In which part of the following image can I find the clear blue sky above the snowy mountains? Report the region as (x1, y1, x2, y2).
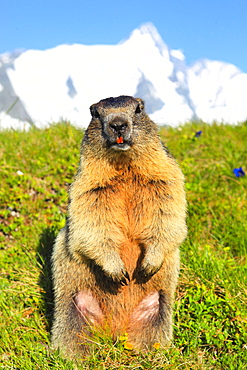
(0, 0, 247, 72)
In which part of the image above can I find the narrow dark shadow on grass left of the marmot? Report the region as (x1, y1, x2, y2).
(37, 227, 58, 331)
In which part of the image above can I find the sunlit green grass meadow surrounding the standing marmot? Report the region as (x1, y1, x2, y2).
(0, 123, 247, 370)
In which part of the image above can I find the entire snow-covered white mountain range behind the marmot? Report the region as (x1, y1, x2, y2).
(0, 23, 247, 128)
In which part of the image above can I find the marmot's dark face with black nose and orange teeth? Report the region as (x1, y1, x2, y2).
(90, 96, 144, 151)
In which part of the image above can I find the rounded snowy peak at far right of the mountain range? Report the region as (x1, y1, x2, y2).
(187, 59, 247, 123)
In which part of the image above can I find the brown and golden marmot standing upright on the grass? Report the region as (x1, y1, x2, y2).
(52, 96, 186, 357)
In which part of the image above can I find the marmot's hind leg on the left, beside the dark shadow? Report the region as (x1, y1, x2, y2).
(52, 227, 103, 357)
